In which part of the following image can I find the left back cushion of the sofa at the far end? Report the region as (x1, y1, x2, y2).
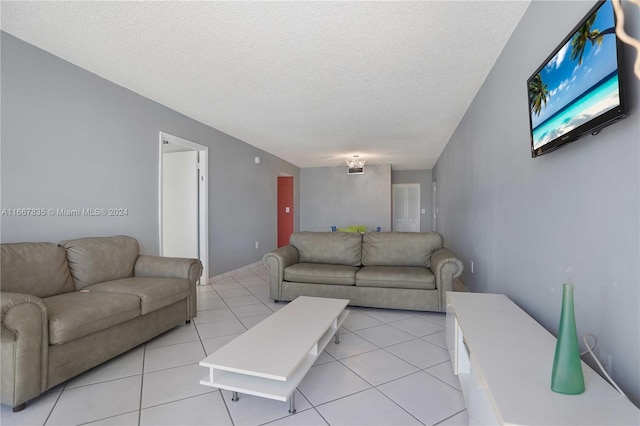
(289, 232, 362, 266)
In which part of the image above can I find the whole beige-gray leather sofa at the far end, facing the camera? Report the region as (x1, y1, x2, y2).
(263, 232, 463, 312)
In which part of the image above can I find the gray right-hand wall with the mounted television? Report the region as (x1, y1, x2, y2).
(434, 1, 640, 404)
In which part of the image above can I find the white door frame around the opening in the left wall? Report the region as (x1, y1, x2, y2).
(158, 132, 209, 285)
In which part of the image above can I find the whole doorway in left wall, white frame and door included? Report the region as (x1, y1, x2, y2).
(159, 132, 209, 284)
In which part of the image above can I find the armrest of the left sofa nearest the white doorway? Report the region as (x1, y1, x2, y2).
(133, 255, 208, 319)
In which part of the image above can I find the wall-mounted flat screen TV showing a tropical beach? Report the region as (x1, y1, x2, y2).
(527, 0, 629, 158)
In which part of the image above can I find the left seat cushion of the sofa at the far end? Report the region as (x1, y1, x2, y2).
(284, 263, 358, 285)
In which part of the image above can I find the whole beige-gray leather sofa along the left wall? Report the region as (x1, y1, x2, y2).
(0, 236, 202, 411)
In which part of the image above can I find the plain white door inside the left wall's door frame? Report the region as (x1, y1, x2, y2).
(162, 151, 199, 259)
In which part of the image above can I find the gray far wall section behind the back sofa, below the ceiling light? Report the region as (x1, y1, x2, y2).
(300, 164, 391, 231)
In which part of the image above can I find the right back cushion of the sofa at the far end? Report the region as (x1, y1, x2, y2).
(362, 232, 444, 268)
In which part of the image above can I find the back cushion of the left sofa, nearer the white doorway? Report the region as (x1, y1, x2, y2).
(60, 235, 140, 290)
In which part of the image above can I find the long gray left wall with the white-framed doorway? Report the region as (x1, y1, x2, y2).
(0, 32, 300, 276)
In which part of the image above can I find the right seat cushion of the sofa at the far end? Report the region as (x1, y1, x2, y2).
(356, 266, 436, 290)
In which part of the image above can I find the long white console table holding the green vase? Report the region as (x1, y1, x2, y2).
(446, 292, 640, 425)
